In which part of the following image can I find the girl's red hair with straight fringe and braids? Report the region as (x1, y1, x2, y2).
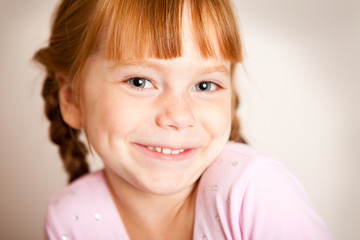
(34, 0, 245, 182)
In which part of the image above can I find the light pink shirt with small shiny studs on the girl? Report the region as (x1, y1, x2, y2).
(45, 142, 333, 240)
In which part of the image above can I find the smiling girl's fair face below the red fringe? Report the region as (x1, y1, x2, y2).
(79, 31, 231, 194)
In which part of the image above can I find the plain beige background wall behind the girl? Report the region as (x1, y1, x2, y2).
(0, 0, 360, 240)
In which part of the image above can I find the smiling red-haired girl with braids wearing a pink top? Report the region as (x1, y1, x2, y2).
(35, 0, 332, 240)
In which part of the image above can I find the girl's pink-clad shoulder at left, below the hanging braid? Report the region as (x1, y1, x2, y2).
(45, 171, 126, 239)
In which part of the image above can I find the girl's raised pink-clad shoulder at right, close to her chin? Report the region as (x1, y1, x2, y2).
(197, 143, 332, 239)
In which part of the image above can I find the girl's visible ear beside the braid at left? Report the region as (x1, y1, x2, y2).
(55, 74, 83, 129)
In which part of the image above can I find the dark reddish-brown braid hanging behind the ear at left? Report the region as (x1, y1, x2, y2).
(42, 74, 89, 182)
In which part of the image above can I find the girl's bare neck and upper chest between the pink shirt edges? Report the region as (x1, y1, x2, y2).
(105, 169, 196, 239)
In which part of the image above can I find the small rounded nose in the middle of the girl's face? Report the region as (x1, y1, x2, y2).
(156, 94, 195, 130)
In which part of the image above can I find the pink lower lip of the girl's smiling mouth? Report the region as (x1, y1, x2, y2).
(133, 143, 196, 161)
